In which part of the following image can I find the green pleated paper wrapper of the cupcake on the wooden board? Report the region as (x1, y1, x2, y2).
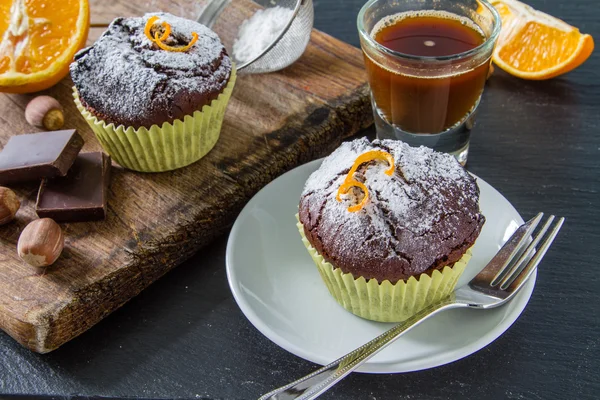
(73, 67, 236, 172)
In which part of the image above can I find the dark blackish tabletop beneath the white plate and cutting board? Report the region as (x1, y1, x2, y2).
(0, 0, 600, 400)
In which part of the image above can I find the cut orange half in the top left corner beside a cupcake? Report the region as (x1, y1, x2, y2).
(0, 0, 90, 93)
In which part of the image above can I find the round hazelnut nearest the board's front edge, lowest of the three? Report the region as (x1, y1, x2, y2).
(17, 218, 65, 267)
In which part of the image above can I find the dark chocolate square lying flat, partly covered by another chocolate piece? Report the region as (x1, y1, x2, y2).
(35, 152, 110, 222)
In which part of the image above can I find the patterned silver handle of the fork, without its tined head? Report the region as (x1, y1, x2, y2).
(259, 294, 461, 400)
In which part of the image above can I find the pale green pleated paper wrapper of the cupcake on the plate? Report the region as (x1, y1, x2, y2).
(297, 217, 471, 322)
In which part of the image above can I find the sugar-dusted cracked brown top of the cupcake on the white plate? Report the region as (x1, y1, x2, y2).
(299, 138, 485, 283)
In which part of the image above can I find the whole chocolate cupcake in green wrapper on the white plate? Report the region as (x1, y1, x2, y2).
(299, 139, 485, 322)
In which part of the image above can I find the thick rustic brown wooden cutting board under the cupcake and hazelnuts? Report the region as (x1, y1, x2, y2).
(0, 0, 372, 353)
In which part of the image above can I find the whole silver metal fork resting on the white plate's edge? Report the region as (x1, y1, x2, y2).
(259, 213, 565, 400)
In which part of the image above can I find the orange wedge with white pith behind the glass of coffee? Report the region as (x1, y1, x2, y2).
(491, 0, 594, 80)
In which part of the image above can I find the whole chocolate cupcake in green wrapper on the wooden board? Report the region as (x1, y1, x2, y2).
(71, 13, 236, 172)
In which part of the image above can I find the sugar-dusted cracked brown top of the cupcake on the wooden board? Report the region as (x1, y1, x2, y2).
(71, 13, 232, 128)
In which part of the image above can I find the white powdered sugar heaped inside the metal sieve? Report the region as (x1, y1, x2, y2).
(233, 6, 294, 63)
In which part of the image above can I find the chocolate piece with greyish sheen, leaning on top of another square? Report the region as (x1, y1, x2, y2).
(0, 129, 83, 185)
